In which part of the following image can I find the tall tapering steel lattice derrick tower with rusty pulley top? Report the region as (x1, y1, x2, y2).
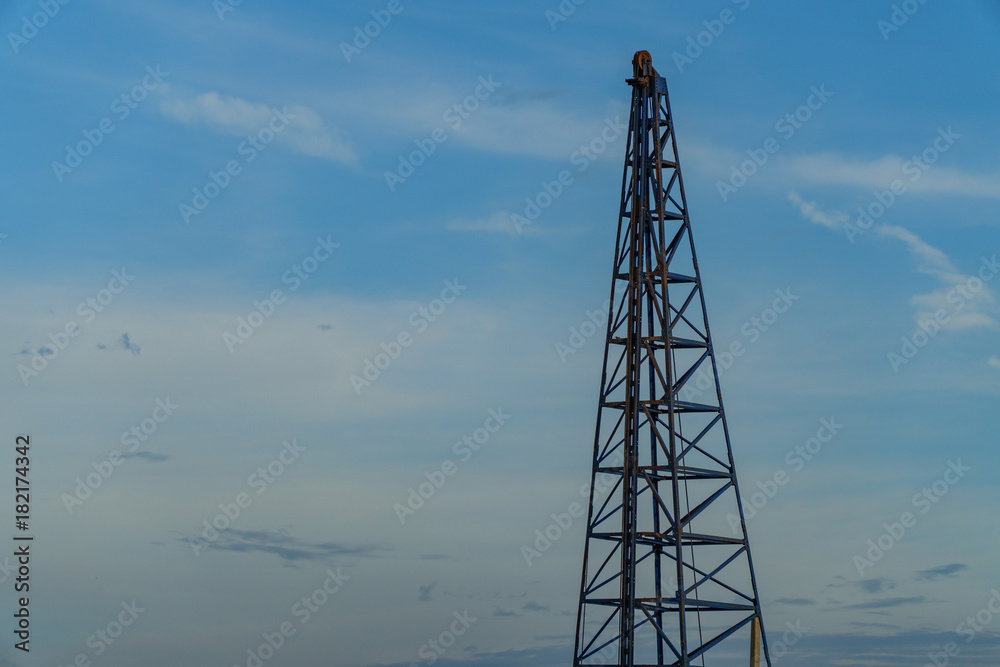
(573, 51, 771, 667)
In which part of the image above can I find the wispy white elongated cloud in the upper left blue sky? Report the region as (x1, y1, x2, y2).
(160, 88, 358, 166)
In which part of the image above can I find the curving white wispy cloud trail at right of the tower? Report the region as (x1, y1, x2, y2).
(788, 191, 998, 331)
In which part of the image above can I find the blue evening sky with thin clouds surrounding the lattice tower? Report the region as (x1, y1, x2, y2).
(0, 0, 1000, 667)
